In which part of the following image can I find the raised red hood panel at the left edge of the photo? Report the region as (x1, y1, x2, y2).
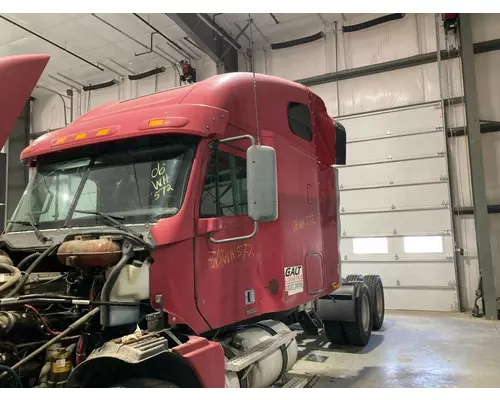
(0, 54, 50, 147)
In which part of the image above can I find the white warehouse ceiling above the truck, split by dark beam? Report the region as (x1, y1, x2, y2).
(0, 14, 344, 96)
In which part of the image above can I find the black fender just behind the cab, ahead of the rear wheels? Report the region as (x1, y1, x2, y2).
(316, 282, 364, 322)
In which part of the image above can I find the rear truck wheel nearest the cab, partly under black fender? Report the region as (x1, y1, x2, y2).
(341, 282, 372, 346)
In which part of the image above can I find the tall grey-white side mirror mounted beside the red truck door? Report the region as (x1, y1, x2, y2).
(247, 145, 278, 222)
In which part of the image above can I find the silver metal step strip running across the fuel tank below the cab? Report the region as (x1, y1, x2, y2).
(226, 331, 297, 372)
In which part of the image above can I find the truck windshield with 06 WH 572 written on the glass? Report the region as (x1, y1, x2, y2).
(7, 138, 196, 232)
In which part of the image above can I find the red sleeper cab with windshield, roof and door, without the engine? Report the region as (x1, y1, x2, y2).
(13, 73, 339, 334)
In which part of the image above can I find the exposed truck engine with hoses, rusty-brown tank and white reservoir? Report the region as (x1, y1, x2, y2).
(0, 236, 152, 387)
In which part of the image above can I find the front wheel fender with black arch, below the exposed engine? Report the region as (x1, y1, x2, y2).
(66, 335, 224, 388)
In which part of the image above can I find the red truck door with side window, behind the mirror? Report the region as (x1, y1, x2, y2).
(195, 142, 258, 326)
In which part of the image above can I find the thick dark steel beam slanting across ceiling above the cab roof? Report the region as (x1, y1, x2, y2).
(167, 14, 241, 74)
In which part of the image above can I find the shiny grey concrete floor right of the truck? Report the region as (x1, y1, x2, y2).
(290, 312, 500, 388)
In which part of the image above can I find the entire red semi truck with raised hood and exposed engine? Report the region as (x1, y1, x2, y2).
(0, 55, 384, 388)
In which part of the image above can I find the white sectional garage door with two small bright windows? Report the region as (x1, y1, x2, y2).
(338, 103, 458, 311)
